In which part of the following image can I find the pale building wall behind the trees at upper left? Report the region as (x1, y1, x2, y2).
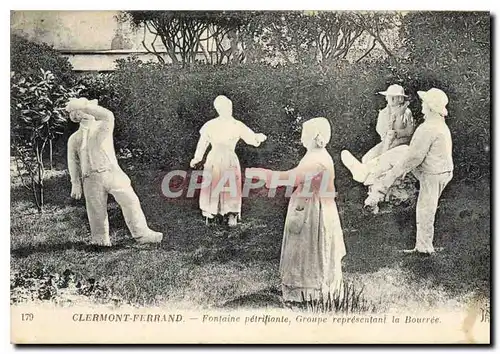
(11, 11, 208, 72)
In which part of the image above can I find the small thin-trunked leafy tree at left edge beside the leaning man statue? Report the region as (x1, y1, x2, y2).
(11, 69, 80, 212)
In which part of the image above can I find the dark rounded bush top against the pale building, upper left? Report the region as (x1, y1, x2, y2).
(10, 35, 75, 84)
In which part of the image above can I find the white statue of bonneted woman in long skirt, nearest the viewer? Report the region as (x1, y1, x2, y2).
(246, 117, 346, 303)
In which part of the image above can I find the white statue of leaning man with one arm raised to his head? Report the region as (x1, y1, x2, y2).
(66, 98, 163, 246)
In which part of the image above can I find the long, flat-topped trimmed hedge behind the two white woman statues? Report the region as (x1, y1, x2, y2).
(101, 61, 398, 176)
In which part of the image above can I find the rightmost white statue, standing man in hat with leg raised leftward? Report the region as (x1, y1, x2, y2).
(341, 88, 454, 254)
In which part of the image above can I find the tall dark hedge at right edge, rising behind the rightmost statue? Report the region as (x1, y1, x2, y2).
(401, 11, 491, 180)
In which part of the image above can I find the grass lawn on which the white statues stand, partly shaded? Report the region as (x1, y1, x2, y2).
(11, 158, 490, 311)
